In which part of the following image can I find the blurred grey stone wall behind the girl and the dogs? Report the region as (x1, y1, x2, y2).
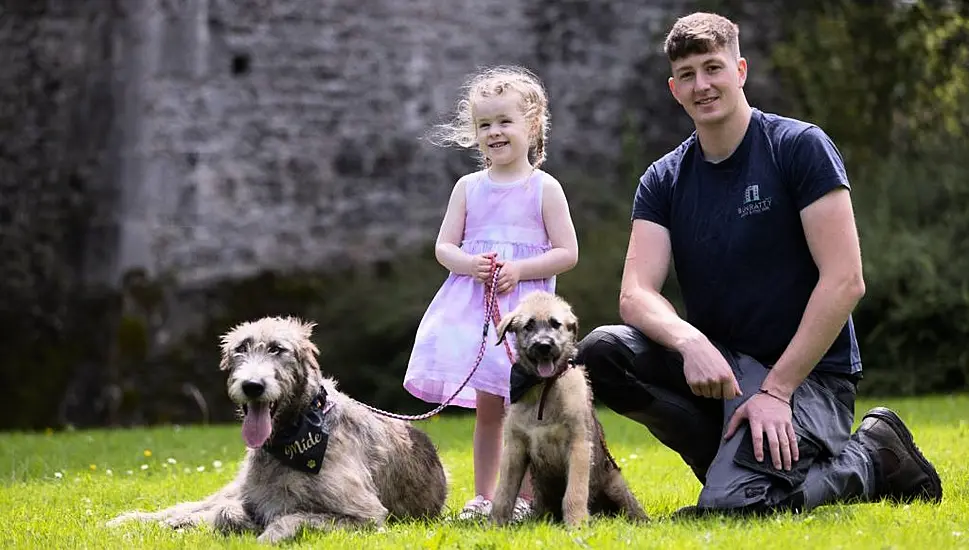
(0, 0, 788, 429)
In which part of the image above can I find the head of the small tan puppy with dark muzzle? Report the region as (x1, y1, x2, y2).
(498, 291, 579, 378)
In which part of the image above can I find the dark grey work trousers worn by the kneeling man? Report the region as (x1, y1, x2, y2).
(576, 325, 875, 513)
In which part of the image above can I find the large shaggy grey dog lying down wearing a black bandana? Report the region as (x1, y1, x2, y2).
(109, 317, 447, 542)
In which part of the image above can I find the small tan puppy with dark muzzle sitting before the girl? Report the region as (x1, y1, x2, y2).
(491, 292, 648, 526)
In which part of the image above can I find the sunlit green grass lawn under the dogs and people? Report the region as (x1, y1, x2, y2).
(0, 396, 969, 550)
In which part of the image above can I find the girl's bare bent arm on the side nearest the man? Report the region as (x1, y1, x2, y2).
(498, 176, 579, 286)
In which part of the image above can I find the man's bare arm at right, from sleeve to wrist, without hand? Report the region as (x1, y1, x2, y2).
(761, 188, 865, 401)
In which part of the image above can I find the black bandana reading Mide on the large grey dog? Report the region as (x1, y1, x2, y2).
(262, 387, 333, 474)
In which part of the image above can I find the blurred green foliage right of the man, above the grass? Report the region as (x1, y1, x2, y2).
(773, 0, 969, 393)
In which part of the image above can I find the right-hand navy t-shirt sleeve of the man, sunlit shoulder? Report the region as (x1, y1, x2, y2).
(788, 126, 851, 210)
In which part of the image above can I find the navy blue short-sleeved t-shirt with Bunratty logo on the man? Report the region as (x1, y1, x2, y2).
(632, 109, 861, 374)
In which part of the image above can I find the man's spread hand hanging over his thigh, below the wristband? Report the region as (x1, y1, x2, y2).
(723, 393, 800, 471)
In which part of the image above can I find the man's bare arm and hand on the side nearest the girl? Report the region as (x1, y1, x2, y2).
(619, 220, 740, 399)
